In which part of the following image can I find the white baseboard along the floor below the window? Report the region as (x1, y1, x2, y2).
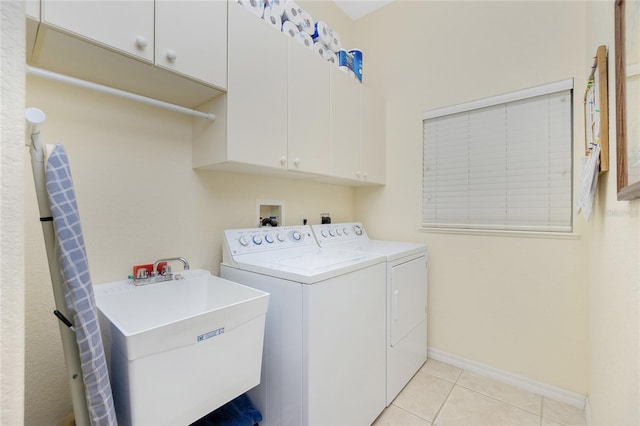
(427, 347, 587, 410)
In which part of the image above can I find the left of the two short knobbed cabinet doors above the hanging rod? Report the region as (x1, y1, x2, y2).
(42, 0, 154, 62)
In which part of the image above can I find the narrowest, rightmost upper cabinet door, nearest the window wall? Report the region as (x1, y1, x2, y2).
(360, 86, 387, 184)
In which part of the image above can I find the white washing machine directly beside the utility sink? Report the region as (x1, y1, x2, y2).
(220, 226, 386, 426)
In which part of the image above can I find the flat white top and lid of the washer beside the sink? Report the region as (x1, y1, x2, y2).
(233, 248, 385, 284)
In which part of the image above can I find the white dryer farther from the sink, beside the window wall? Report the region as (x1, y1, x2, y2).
(312, 223, 427, 405)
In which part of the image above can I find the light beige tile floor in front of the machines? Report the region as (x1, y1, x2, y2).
(374, 359, 587, 426)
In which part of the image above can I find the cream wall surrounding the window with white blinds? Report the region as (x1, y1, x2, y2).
(356, 0, 591, 395)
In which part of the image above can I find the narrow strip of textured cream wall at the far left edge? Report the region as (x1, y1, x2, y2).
(0, 1, 25, 425)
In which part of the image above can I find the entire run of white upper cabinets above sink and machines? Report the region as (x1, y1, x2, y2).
(37, 0, 386, 185)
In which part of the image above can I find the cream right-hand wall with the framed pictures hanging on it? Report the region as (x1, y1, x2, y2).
(585, 1, 640, 425)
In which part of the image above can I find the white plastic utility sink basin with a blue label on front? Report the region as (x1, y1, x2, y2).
(94, 269, 269, 425)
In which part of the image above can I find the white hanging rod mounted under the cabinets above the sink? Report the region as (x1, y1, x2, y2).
(27, 65, 216, 121)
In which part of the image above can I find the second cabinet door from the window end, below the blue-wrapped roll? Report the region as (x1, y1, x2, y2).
(331, 68, 361, 179)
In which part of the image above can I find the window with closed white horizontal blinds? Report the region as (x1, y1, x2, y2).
(422, 80, 573, 232)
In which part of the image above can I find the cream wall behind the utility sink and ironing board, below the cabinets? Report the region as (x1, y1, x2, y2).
(24, 77, 353, 425)
